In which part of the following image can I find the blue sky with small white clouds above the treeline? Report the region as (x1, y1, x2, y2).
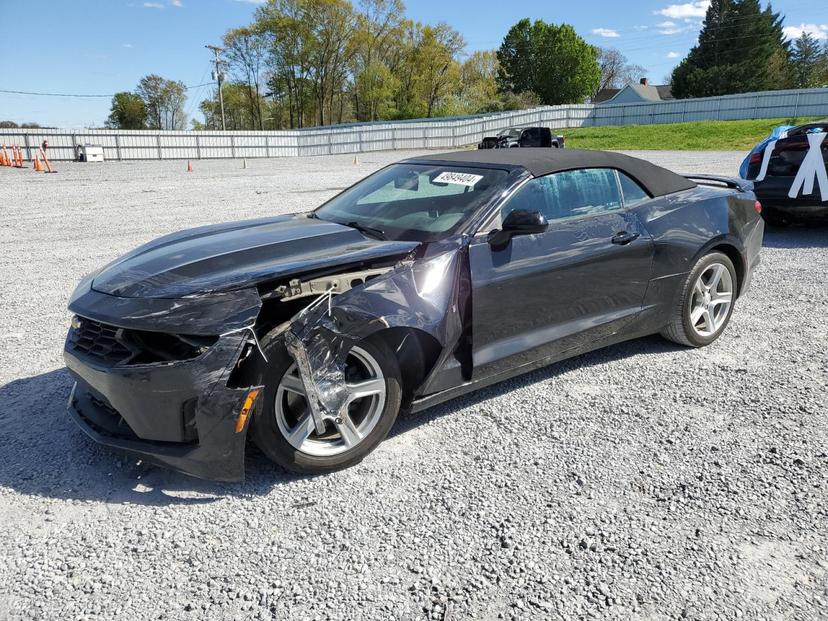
(0, 0, 828, 127)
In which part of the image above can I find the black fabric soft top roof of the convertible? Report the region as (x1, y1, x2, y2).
(405, 148, 696, 196)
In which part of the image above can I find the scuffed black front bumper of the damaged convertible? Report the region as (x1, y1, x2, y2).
(64, 333, 253, 481)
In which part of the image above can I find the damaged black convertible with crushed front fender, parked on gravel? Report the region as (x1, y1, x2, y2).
(65, 149, 763, 481)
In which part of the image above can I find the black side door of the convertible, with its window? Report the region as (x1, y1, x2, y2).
(469, 169, 653, 378)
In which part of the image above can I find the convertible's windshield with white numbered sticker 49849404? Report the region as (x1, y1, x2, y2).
(313, 164, 508, 241)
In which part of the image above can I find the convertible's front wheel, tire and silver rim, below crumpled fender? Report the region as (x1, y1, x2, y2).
(252, 340, 402, 474)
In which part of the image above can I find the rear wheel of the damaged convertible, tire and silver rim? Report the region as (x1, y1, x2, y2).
(661, 252, 738, 347)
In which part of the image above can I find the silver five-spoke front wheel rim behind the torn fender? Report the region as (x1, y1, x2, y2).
(274, 346, 386, 457)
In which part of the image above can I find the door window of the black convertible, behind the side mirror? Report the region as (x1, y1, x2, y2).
(500, 168, 621, 222)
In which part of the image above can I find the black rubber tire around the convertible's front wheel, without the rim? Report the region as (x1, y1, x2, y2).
(251, 337, 402, 474)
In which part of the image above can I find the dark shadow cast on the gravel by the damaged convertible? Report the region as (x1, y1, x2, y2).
(0, 337, 682, 506)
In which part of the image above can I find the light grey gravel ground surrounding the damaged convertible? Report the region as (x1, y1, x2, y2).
(0, 152, 828, 620)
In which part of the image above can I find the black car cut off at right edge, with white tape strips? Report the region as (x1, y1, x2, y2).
(741, 119, 828, 225)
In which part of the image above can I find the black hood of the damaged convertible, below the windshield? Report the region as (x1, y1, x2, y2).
(92, 215, 418, 298)
